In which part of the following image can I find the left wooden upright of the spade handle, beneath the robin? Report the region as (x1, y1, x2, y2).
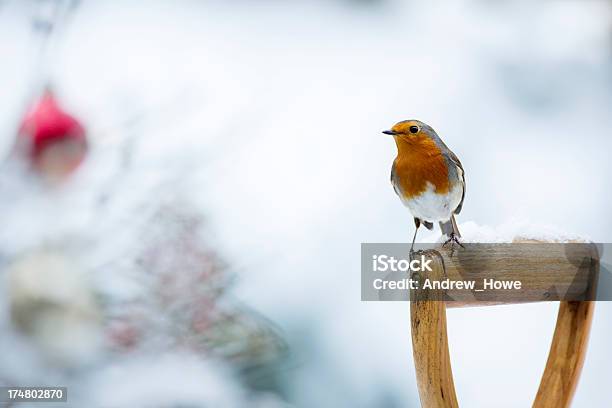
(410, 253, 458, 408)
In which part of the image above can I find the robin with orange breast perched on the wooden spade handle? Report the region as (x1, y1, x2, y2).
(383, 120, 465, 252)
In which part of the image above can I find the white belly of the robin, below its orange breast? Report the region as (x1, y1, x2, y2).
(402, 183, 463, 222)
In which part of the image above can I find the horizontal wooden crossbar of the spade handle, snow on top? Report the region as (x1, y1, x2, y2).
(428, 242, 598, 308)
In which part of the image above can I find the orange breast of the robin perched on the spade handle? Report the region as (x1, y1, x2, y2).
(393, 135, 451, 199)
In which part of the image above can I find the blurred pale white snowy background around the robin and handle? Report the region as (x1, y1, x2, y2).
(0, 0, 612, 407)
